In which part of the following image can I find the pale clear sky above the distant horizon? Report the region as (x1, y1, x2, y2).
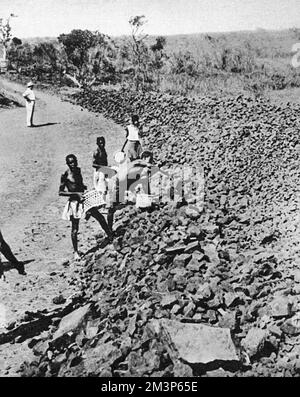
(0, 0, 300, 38)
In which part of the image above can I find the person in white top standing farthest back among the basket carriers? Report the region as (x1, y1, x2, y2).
(122, 114, 142, 161)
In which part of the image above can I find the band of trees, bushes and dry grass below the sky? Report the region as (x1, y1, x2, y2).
(8, 25, 300, 95)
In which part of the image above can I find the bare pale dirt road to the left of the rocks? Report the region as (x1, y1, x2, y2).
(0, 80, 124, 376)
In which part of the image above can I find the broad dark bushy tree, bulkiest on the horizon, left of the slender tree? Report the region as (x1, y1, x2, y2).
(58, 29, 113, 87)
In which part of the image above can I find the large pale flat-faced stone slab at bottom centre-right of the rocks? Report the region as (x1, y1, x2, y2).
(161, 319, 240, 364)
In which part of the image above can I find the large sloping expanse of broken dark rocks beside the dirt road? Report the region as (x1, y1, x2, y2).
(19, 90, 300, 377)
